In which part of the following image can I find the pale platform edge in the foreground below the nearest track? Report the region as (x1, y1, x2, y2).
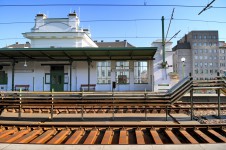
(0, 144, 226, 150)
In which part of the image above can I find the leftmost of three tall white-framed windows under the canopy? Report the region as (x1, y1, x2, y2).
(97, 61, 111, 84)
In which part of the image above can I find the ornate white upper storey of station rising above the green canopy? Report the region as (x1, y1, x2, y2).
(23, 13, 98, 48)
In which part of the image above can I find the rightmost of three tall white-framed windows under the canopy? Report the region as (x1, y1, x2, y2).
(134, 61, 148, 83)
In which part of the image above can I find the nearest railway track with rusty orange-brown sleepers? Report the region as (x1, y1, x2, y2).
(0, 124, 226, 145)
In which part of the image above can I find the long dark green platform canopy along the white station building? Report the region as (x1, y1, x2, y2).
(0, 47, 157, 62)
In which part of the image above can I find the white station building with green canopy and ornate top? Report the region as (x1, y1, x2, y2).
(0, 13, 157, 91)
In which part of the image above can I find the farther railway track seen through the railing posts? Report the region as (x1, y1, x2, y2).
(3, 103, 226, 116)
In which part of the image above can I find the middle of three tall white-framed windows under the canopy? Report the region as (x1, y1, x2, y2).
(116, 61, 129, 84)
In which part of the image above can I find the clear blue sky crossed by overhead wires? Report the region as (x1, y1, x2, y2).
(0, 0, 226, 47)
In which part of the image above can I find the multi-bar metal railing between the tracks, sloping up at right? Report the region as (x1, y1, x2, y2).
(0, 76, 226, 106)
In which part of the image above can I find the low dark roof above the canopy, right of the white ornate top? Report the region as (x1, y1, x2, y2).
(94, 40, 135, 47)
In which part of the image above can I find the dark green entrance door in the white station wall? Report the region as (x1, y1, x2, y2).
(50, 66, 64, 92)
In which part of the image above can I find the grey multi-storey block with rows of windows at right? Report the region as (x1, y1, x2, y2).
(173, 31, 225, 80)
